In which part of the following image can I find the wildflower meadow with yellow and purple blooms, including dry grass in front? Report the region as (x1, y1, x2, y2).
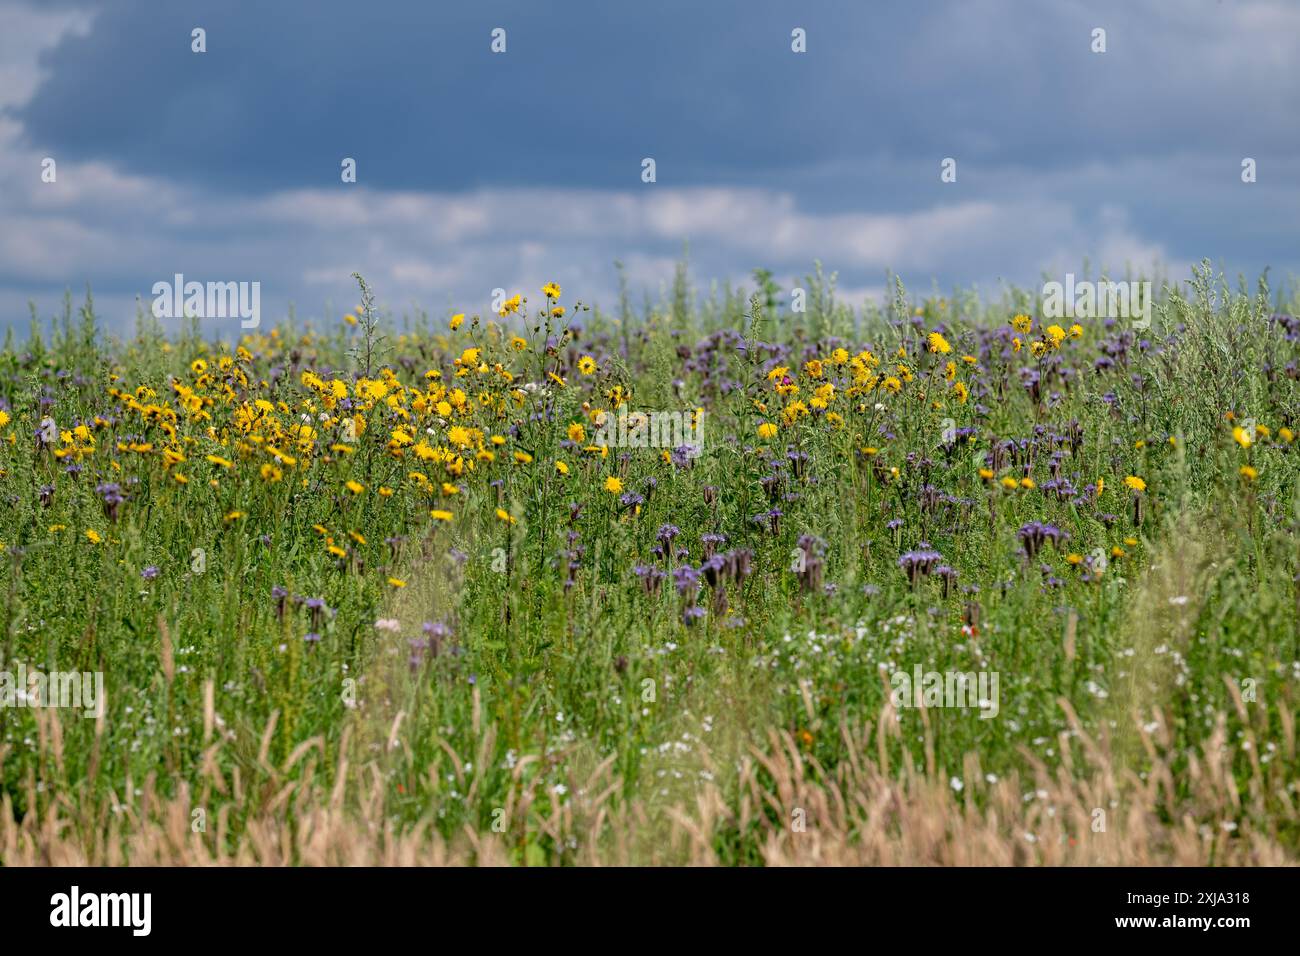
(0, 267, 1300, 865)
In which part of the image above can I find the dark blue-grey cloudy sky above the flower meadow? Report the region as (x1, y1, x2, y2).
(0, 0, 1300, 329)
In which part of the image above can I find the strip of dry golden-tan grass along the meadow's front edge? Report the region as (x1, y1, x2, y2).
(0, 701, 1296, 866)
